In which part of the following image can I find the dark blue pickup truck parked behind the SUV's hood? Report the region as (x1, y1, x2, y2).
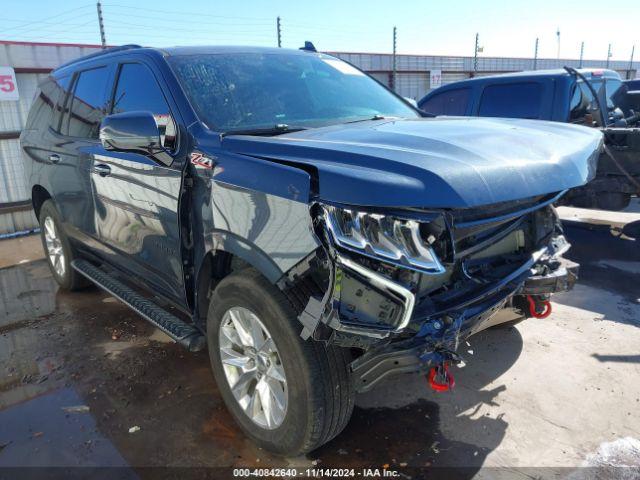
(418, 68, 640, 210)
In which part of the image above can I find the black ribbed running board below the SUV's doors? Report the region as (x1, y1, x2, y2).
(71, 260, 206, 352)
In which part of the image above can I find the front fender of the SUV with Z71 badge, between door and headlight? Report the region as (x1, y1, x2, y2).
(190, 136, 319, 324)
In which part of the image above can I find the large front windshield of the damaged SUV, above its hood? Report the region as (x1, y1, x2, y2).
(168, 53, 419, 132)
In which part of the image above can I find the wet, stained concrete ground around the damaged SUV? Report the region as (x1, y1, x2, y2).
(0, 212, 640, 478)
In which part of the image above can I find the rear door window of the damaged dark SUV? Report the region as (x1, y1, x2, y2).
(61, 67, 109, 138)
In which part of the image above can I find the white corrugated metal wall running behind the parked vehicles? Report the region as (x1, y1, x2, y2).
(0, 41, 640, 235)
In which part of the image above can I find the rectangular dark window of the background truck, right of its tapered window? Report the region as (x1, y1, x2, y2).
(478, 82, 542, 119)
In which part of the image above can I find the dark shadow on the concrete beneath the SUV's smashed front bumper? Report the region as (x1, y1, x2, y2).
(311, 327, 523, 478)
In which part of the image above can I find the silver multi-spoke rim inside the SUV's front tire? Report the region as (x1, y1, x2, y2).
(218, 307, 288, 430)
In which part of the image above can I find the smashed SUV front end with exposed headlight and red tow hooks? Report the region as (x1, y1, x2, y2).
(280, 189, 578, 391)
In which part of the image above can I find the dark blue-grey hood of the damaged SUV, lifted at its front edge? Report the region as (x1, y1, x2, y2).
(222, 117, 602, 208)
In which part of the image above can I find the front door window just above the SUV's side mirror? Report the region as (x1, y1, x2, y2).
(112, 63, 176, 150)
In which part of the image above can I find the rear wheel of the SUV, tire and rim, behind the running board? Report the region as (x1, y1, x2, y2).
(39, 200, 91, 291)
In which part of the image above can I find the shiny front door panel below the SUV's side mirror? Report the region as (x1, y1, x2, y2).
(91, 152, 184, 302)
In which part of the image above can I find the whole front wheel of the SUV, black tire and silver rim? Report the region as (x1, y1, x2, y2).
(207, 269, 355, 456)
